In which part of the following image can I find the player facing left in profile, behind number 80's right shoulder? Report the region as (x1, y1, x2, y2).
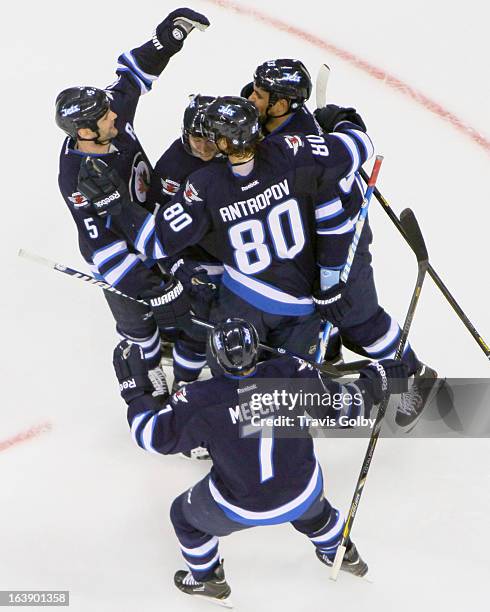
(242, 59, 438, 428)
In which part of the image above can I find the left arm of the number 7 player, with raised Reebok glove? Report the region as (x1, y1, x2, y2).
(113, 341, 208, 455)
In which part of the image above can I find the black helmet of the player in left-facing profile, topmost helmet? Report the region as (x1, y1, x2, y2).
(254, 59, 312, 110)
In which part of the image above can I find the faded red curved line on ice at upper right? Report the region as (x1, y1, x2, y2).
(204, 0, 490, 153)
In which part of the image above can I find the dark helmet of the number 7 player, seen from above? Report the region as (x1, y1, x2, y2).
(208, 319, 259, 376)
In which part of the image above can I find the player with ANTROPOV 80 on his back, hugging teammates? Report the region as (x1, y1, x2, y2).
(80, 97, 373, 366)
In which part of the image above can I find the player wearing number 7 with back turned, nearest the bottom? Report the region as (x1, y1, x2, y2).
(114, 319, 407, 601)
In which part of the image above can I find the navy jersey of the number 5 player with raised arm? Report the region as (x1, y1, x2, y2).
(58, 34, 185, 297)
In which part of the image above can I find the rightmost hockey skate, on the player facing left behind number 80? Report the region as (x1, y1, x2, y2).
(395, 363, 442, 433)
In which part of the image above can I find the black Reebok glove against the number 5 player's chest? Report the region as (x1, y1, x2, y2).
(78, 157, 129, 217)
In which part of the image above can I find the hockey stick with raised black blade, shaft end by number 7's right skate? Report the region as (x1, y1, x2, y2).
(330, 208, 429, 580)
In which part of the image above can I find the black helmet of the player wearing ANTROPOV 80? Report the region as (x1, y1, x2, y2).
(202, 96, 260, 149)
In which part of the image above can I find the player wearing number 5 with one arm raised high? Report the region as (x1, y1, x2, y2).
(56, 8, 209, 392)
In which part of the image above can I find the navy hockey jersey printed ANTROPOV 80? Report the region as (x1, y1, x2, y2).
(115, 123, 373, 316)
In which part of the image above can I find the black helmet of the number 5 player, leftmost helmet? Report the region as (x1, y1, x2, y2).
(55, 87, 110, 138)
